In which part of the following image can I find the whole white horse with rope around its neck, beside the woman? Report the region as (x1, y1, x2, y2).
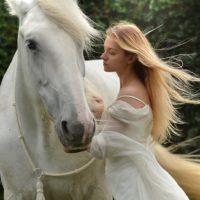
(0, 0, 119, 200)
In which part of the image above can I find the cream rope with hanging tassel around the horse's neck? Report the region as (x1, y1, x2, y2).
(13, 64, 95, 200)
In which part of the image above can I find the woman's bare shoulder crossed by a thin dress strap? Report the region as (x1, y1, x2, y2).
(118, 86, 150, 108)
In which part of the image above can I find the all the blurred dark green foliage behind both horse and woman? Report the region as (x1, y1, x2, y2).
(0, 0, 200, 200)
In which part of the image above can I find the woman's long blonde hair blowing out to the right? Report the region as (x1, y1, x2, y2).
(107, 22, 200, 142)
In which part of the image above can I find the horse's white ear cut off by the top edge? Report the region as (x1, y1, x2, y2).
(6, 0, 35, 18)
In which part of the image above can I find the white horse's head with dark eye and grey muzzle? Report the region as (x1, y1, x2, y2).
(7, 0, 98, 151)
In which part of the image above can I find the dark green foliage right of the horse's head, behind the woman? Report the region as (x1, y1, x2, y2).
(80, 0, 200, 150)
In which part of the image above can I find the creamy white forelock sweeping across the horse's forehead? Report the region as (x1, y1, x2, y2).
(36, 0, 99, 49)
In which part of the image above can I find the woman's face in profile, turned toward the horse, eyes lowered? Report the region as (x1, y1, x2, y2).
(101, 36, 133, 73)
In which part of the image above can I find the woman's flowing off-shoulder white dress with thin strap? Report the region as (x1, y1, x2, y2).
(90, 95, 189, 200)
